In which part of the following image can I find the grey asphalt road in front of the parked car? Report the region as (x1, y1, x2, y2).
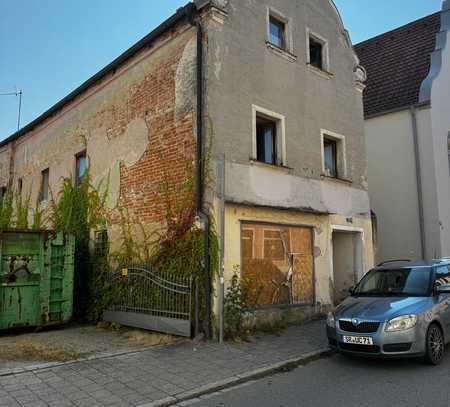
(185, 349, 450, 407)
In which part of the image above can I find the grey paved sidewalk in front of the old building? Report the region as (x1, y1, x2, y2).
(0, 321, 326, 407)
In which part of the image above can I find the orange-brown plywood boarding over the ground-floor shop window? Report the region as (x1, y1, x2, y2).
(241, 224, 314, 305)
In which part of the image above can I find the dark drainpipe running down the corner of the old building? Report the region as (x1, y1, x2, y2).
(188, 3, 211, 339)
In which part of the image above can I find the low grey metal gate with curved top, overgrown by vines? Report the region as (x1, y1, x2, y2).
(103, 265, 192, 337)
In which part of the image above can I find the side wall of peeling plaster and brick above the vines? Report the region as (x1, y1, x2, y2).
(2, 23, 196, 236)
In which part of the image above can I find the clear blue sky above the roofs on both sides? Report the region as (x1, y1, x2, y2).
(0, 0, 441, 140)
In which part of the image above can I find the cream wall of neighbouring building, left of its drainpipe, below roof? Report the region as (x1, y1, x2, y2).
(365, 110, 421, 261)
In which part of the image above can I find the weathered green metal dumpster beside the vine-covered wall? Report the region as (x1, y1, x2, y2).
(0, 230, 75, 329)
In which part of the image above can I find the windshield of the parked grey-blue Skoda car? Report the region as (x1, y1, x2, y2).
(353, 267, 431, 297)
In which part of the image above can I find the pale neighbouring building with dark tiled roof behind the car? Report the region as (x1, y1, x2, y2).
(355, 0, 450, 261)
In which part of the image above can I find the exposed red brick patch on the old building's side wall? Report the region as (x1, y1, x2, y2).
(105, 32, 195, 223)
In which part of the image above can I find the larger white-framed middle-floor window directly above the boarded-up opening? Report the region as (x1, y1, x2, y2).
(252, 105, 286, 166)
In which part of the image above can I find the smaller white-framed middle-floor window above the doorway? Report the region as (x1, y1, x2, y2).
(321, 130, 347, 179)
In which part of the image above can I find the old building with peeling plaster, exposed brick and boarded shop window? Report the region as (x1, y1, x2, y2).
(0, 0, 373, 326)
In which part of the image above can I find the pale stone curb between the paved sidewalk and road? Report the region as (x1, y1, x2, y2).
(138, 348, 333, 407)
